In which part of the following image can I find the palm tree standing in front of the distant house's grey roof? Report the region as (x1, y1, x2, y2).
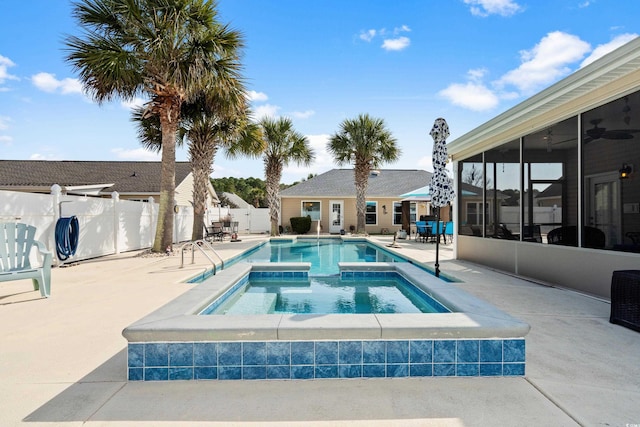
(327, 114, 400, 234)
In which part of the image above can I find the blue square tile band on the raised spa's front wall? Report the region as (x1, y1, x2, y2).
(128, 338, 525, 381)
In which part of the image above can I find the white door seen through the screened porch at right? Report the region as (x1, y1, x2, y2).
(587, 173, 620, 247)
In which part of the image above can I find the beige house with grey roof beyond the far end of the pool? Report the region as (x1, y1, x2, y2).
(280, 169, 432, 234)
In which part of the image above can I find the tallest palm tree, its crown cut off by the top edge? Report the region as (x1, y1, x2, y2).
(66, 0, 243, 252)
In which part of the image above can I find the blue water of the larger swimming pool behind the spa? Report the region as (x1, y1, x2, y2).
(230, 239, 406, 276)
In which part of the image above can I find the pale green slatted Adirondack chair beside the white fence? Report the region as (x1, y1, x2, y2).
(0, 222, 53, 298)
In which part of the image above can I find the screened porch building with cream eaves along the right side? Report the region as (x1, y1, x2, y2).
(447, 38, 640, 298)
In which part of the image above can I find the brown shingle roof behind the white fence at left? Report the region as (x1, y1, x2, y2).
(0, 160, 191, 194)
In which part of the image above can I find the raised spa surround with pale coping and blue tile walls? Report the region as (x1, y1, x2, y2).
(123, 263, 529, 381)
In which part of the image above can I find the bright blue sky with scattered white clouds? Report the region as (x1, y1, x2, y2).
(0, 0, 640, 185)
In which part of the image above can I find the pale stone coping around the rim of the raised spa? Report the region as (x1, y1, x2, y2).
(122, 262, 530, 343)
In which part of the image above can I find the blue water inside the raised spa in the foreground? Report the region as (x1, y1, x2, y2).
(201, 272, 449, 315)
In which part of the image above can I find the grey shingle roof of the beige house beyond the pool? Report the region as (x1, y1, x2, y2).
(280, 169, 432, 198)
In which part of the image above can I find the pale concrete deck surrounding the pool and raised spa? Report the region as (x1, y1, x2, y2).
(0, 236, 640, 426)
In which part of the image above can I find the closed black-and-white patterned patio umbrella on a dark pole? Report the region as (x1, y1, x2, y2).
(429, 118, 456, 277)
